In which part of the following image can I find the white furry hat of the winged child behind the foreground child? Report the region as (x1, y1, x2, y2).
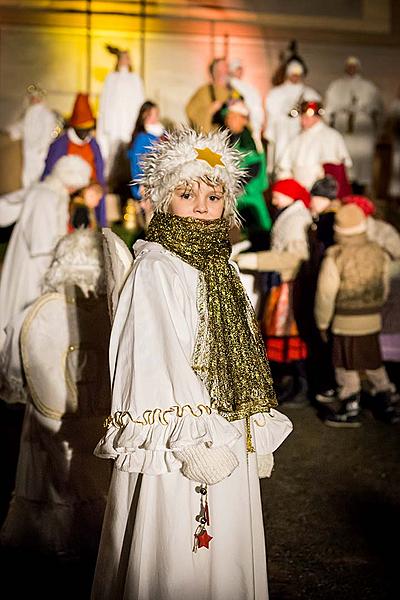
(42, 229, 106, 297)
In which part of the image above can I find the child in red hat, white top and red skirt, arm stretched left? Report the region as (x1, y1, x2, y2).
(235, 179, 312, 405)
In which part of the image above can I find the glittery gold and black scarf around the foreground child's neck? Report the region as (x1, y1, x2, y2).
(146, 213, 277, 421)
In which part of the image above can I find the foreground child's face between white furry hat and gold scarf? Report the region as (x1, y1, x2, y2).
(169, 180, 225, 221)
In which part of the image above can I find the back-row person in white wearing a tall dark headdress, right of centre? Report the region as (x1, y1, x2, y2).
(264, 60, 321, 173)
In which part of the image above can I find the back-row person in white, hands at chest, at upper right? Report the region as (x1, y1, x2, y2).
(325, 56, 384, 193)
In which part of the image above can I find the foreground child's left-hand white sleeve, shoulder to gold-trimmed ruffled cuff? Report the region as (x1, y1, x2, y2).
(95, 246, 240, 475)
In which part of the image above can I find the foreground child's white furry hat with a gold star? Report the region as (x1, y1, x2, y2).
(136, 128, 245, 223)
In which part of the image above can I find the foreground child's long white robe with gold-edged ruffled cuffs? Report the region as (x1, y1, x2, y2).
(92, 240, 292, 600)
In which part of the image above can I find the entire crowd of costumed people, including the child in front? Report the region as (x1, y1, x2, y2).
(0, 39, 400, 600)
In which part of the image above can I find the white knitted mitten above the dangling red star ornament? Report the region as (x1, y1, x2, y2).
(174, 444, 239, 485)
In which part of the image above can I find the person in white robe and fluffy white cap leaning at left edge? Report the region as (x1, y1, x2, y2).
(0, 155, 91, 348)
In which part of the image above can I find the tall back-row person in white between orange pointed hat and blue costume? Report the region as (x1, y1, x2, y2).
(96, 46, 145, 175)
